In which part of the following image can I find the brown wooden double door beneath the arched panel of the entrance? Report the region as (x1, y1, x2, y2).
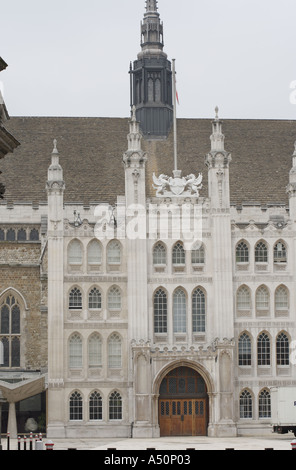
(159, 398, 207, 436)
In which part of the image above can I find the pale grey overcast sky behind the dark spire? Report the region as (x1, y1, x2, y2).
(0, 0, 296, 119)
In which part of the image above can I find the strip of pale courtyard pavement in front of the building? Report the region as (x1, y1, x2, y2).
(2, 434, 296, 452)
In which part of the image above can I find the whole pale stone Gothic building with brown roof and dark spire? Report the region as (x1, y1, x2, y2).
(0, 1, 296, 438)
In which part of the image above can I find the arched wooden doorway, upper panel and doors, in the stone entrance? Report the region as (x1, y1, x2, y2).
(158, 366, 209, 436)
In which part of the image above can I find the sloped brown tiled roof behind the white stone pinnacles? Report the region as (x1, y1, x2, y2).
(1, 117, 296, 204)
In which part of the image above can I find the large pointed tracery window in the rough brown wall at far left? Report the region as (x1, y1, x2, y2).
(0, 294, 21, 367)
